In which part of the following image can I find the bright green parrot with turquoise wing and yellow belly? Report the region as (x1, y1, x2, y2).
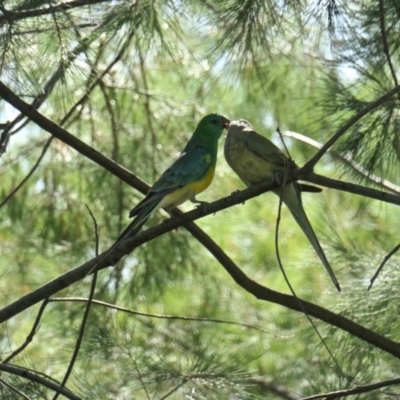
(118, 114, 230, 240)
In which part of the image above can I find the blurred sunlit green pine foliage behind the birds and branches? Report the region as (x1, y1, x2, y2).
(0, 0, 400, 400)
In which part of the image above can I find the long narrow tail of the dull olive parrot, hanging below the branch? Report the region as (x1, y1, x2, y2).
(276, 184, 340, 292)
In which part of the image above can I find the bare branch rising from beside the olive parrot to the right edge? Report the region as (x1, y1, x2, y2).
(303, 85, 400, 170)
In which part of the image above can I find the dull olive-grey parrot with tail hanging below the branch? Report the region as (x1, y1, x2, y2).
(224, 119, 340, 291)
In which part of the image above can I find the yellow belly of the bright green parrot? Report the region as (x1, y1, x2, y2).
(158, 168, 215, 208)
